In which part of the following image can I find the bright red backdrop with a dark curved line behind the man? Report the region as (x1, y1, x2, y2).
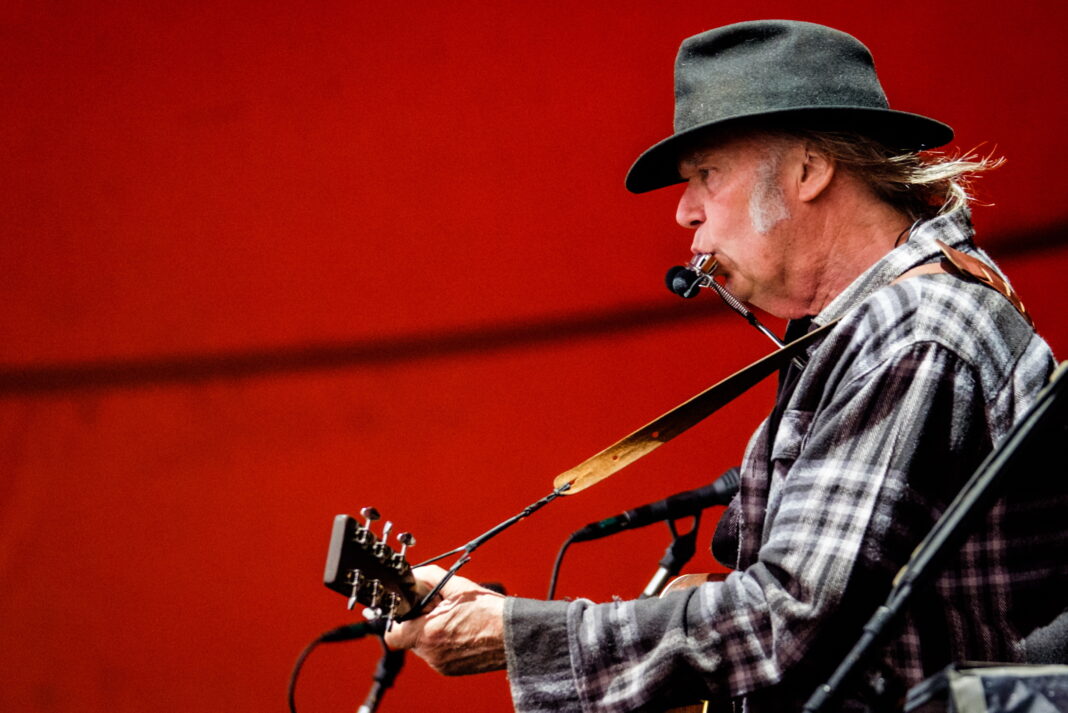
(0, 0, 1068, 713)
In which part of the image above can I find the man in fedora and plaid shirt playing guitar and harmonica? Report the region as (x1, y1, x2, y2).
(387, 21, 1068, 712)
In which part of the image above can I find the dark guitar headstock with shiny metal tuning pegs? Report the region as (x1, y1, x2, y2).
(323, 508, 419, 620)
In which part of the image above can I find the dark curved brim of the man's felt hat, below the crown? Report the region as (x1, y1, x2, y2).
(626, 107, 953, 193)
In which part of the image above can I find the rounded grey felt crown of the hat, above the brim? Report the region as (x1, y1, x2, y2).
(675, 20, 889, 131)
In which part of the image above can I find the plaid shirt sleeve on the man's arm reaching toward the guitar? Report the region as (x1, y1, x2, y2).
(505, 342, 986, 713)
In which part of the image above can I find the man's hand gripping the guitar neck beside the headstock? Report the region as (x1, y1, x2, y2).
(386, 565, 505, 676)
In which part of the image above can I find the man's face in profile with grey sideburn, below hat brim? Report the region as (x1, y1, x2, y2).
(675, 132, 792, 316)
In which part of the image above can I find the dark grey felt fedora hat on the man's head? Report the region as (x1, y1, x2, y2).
(627, 20, 953, 193)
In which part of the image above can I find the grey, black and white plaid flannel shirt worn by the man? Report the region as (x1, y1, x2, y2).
(505, 211, 1068, 713)
